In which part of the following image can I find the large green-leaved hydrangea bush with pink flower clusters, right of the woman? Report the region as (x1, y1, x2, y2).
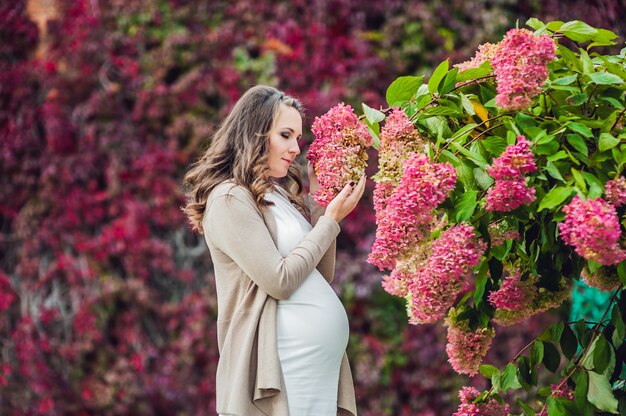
(346, 19, 626, 415)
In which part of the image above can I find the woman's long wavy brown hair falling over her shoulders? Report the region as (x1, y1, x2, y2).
(182, 85, 308, 234)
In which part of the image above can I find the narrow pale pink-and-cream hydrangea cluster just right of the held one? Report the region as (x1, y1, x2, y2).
(372, 108, 423, 223)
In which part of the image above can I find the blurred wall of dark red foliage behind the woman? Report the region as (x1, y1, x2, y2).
(0, 0, 623, 415)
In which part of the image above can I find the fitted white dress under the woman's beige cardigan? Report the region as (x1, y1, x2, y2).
(265, 191, 348, 416)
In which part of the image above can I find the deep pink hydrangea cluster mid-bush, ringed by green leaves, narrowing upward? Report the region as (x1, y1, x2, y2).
(485, 136, 537, 212)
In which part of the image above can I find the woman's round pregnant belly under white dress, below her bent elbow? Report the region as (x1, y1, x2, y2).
(277, 271, 348, 371)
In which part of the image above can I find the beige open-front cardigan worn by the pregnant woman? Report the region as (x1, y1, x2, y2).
(203, 182, 356, 416)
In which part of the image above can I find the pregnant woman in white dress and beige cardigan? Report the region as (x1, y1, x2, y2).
(184, 86, 365, 416)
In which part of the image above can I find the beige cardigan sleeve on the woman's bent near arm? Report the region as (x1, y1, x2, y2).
(204, 193, 340, 299)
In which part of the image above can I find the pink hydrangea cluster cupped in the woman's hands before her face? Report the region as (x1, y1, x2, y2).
(307, 103, 372, 206)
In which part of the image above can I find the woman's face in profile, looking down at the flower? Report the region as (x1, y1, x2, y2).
(267, 104, 302, 178)
